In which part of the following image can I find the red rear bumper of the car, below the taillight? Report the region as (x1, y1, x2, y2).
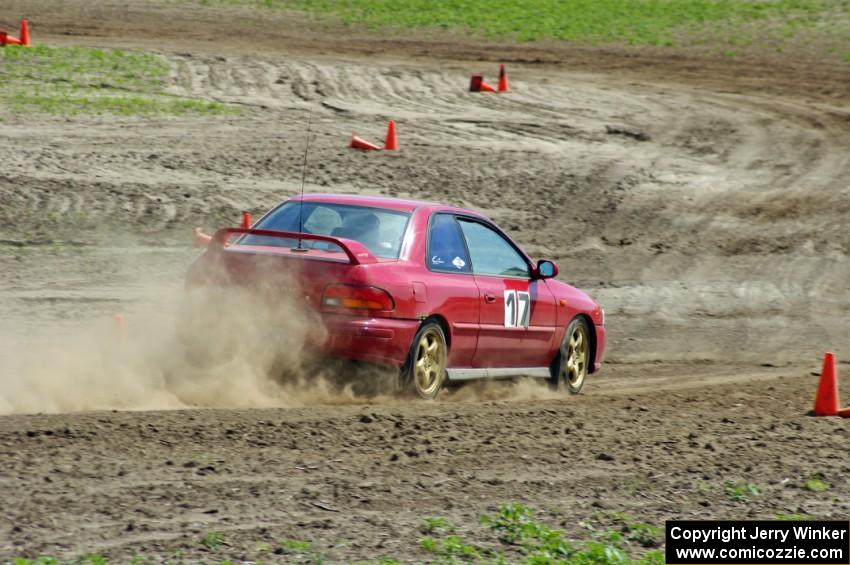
(316, 315, 419, 367)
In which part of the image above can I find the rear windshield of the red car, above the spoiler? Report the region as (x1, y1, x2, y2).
(239, 201, 410, 259)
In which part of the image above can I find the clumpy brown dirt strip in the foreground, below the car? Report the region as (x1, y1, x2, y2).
(0, 368, 850, 562)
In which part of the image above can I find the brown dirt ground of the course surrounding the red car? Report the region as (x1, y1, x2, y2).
(0, 0, 850, 562)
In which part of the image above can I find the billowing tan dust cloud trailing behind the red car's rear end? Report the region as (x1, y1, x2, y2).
(0, 289, 322, 413)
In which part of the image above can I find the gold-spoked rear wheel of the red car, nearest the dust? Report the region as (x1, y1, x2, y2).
(402, 321, 449, 400)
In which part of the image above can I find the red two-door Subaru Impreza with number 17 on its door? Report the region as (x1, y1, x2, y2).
(187, 194, 605, 398)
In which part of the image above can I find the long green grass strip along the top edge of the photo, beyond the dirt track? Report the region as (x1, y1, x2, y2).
(205, 0, 850, 45)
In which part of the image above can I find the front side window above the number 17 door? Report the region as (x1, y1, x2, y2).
(459, 220, 531, 278)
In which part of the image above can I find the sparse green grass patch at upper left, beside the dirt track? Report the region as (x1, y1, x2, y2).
(0, 45, 233, 116)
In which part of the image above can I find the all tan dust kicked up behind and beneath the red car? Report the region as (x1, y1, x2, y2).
(0, 253, 562, 414)
